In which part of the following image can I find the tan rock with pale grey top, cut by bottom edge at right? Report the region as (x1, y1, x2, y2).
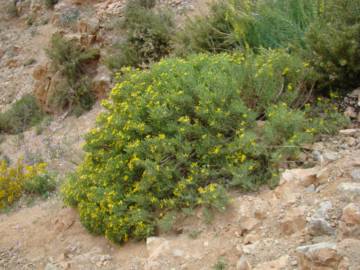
(296, 242, 342, 270)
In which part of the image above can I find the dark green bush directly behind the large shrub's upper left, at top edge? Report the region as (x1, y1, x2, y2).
(107, 0, 174, 69)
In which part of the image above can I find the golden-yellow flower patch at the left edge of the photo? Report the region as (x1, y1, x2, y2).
(0, 160, 47, 209)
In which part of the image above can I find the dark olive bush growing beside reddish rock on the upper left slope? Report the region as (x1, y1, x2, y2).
(47, 33, 99, 114)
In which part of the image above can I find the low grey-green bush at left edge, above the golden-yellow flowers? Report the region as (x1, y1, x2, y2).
(0, 95, 44, 134)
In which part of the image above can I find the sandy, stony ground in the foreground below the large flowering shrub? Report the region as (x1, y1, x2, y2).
(0, 129, 360, 270)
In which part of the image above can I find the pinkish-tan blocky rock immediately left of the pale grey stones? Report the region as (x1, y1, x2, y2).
(280, 208, 306, 235)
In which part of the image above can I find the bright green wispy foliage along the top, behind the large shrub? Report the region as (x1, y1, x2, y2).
(176, 0, 319, 54)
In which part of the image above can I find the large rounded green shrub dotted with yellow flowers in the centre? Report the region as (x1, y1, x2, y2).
(63, 50, 348, 242)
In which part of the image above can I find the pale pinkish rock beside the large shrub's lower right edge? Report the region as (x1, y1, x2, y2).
(280, 167, 319, 187)
